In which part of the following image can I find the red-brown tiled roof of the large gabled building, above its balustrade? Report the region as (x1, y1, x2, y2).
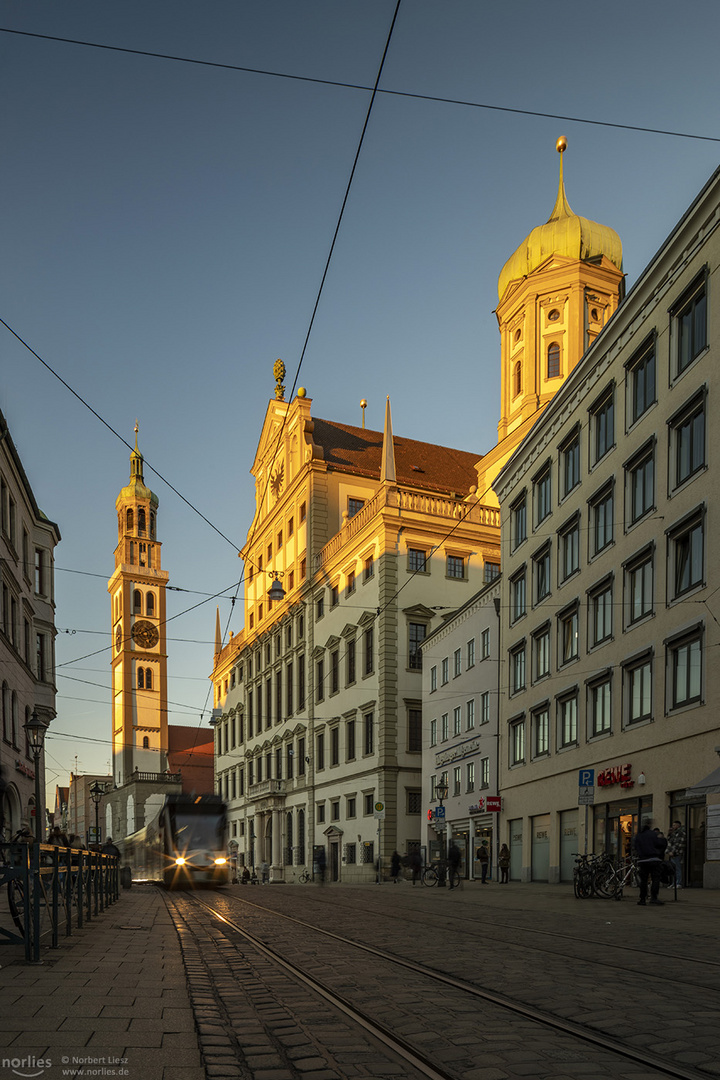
(312, 419, 481, 496)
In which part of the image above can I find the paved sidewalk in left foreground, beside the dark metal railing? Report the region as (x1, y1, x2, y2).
(0, 887, 205, 1080)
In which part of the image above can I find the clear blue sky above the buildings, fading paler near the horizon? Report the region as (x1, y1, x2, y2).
(0, 0, 720, 789)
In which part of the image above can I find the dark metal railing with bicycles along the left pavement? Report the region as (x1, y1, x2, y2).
(0, 842, 120, 963)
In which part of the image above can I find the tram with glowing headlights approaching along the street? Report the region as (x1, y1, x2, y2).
(122, 795, 229, 889)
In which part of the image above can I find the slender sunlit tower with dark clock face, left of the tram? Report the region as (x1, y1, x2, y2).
(108, 423, 168, 787)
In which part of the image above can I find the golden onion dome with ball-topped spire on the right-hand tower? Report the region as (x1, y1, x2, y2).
(498, 137, 623, 299)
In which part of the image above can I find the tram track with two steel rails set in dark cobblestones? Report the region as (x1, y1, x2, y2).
(168, 893, 715, 1080)
